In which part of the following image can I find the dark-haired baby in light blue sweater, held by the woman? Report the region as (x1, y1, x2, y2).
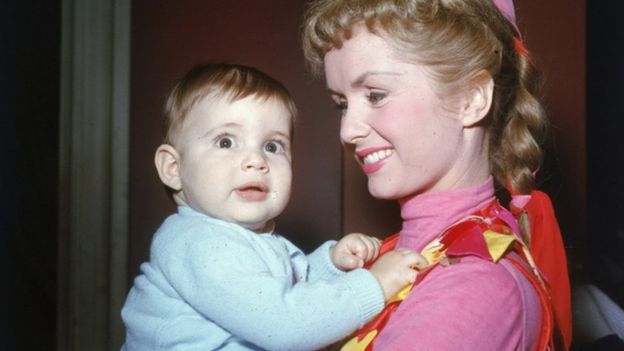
(122, 64, 426, 350)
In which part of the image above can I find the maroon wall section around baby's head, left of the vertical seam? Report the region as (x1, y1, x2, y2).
(129, 0, 341, 276)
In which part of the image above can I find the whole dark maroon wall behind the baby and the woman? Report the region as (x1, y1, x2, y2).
(129, 0, 586, 284)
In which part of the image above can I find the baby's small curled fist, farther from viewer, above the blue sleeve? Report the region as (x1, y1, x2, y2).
(330, 233, 381, 271)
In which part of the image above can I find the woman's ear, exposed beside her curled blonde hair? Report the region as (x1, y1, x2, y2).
(461, 71, 494, 127)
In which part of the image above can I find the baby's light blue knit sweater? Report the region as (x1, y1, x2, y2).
(122, 207, 383, 351)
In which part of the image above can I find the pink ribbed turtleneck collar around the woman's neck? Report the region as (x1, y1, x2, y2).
(397, 177, 494, 252)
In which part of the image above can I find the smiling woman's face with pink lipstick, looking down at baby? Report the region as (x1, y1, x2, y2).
(324, 27, 487, 199)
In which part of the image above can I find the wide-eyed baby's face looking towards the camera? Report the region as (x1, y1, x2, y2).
(176, 96, 292, 231)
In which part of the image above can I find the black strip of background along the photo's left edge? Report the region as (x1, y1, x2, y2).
(0, 1, 61, 350)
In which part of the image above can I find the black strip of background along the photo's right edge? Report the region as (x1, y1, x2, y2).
(585, 0, 624, 306)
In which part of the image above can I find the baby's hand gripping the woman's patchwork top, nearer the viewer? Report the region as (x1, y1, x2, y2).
(370, 248, 427, 301)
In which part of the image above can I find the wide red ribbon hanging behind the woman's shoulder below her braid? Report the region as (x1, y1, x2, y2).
(525, 191, 572, 350)
